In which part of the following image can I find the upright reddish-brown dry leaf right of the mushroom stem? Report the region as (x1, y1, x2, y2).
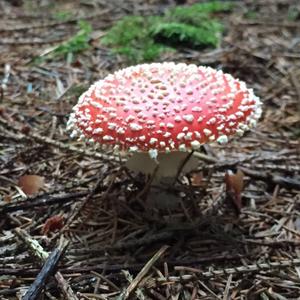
(225, 170, 244, 212)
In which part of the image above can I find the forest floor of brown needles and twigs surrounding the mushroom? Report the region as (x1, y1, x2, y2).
(0, 0, 300, 300)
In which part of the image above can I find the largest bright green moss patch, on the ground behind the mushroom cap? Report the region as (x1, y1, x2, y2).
(101, 1, 232, 63)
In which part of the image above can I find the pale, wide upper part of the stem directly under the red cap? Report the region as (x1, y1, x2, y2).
(125, 151, 198, 183)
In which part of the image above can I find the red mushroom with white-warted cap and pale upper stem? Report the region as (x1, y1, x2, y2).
(68, 62, 261, 178)
